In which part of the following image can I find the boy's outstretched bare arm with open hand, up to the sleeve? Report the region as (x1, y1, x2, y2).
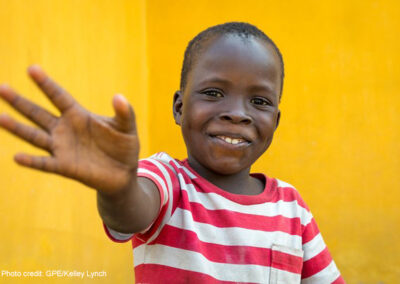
(0, 65, 160, 233)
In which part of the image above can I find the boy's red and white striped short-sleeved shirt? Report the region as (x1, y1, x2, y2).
(106, 153, 345, 284)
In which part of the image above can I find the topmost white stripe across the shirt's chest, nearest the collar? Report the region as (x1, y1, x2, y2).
(178, 178, 312, 226)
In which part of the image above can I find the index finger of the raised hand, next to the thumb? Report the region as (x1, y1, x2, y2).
(28, 65, 76, 113)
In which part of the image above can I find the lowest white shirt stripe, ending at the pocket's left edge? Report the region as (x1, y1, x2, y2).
(133, 245, 270, 283)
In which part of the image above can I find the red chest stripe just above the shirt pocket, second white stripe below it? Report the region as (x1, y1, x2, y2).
(178, 191, 303, 236)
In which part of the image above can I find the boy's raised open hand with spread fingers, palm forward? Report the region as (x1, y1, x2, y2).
(0, 65, 139, 193)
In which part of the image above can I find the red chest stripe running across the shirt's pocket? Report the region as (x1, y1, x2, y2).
(150, 225, 302, 274)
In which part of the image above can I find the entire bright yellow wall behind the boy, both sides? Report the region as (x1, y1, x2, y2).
(0, 0, 400, 284)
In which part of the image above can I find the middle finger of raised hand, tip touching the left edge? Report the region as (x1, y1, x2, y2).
(0, 82, 57, 130)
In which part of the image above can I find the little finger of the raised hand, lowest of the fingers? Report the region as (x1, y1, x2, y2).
(14, 153, 58, 173)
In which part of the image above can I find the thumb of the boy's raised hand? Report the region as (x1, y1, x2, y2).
(113, 94, 136, 133)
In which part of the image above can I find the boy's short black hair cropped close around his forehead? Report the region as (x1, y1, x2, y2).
(180, 22, 285, 98)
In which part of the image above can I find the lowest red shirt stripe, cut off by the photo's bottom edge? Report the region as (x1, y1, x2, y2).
(135, 264, 253, 284)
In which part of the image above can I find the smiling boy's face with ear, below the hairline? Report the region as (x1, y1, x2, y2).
(174, 35, 282, 175)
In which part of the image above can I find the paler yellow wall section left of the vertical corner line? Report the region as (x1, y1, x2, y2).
(0, 0, 149, 283)
